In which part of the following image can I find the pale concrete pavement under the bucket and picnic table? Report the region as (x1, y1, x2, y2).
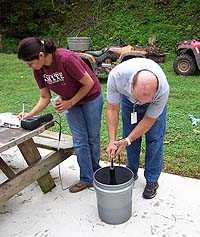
(0, 148, 200, 237)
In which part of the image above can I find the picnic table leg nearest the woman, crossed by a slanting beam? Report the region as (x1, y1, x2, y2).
(18, 138, 56, 193)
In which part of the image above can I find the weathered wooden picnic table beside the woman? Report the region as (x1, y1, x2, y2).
(0, 121, 73, 205)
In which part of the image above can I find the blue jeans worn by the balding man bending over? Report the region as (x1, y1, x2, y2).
(121, 96, 167, 182)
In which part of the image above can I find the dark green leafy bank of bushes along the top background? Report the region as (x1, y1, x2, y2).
(0, 0, 200, 51)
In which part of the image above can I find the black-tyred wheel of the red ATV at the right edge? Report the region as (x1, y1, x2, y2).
(173, 54, 197, 76)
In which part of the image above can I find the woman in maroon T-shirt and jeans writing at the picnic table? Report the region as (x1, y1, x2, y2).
(18, 37, 103, 193)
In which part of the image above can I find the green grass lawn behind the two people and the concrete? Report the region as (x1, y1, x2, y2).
(0, 54, 200, 178)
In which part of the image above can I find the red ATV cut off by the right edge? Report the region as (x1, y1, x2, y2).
(173, 40, 200, 76)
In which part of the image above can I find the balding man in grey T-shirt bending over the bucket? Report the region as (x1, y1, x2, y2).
(107, 58, 169, 199)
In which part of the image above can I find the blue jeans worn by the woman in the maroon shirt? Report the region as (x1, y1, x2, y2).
(65, 95, 103, 184)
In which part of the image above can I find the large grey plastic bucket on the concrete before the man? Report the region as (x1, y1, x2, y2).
(94, 166, 134, 225)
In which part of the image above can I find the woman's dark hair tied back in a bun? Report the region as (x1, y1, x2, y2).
(18, 37, 56, 61)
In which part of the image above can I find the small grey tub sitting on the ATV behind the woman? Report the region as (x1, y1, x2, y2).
(67, 37, 90, 51)
